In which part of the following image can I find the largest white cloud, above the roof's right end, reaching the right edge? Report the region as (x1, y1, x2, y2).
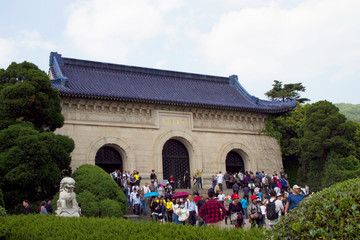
(199, 0, 360, 99)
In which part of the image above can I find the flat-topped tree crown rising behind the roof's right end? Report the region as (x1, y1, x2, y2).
(265, 80, 310, 103)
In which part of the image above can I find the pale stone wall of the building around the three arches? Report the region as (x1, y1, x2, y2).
(57, 98, 282, 184)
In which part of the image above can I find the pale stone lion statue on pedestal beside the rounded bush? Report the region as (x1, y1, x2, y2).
(55, 177, 80, 217)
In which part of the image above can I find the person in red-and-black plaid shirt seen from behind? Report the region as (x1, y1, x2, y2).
(199, 191, 226, 228)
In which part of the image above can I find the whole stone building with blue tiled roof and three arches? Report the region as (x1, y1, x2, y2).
(49, 52, 295, 186)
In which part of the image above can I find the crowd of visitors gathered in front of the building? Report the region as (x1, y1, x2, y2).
(23, 169, 311, 231)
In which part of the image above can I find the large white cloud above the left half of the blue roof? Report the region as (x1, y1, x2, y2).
(65, 0, 182, 61)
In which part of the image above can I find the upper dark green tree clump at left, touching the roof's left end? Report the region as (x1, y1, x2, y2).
(0, 62, 64, 131)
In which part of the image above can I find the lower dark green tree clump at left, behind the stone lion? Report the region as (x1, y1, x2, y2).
(0, 123, 74, 211)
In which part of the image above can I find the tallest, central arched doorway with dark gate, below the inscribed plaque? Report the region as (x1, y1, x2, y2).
(162, 139, 190, 188)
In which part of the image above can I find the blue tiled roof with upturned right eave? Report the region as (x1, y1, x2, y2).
(50, 52, 296, 113)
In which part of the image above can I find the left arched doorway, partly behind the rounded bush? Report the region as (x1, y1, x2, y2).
(95, 146, 123, 173)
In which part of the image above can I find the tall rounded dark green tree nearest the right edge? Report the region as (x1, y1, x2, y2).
(298, 101, 359, 190)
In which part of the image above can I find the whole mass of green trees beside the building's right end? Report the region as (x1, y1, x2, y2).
(265, 101, 360, 190)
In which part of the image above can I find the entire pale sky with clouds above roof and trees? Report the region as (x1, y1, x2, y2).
(0, 0, 360, 104)
